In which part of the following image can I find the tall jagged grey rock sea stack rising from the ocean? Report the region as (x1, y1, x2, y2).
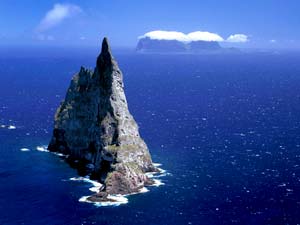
(48, 38, 158, 201)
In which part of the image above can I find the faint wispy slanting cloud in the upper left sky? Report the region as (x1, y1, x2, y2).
(37, 4, 82, 31)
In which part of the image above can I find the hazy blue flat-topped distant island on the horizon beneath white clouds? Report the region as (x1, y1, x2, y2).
(136, 37, 239, 53)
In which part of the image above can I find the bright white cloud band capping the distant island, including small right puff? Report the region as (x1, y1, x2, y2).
(139, 30, 249, 43)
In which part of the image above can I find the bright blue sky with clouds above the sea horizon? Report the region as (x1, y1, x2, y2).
(0, 0, 300, 49)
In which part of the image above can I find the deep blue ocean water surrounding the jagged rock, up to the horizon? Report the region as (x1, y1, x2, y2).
(0, 49, 300, 225)
